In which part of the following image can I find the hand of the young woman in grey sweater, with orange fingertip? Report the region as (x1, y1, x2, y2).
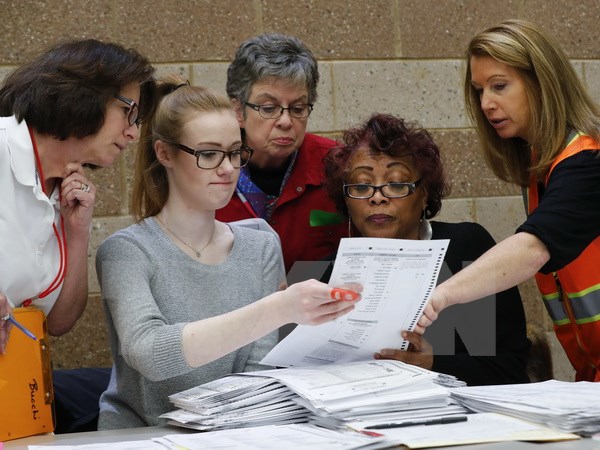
(281, 280, 362, 325)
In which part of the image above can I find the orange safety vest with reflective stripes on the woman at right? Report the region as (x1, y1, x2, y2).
(528, 134, 600, 381)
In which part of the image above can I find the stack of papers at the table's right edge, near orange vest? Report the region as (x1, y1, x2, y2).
(452, 380, 600, 436)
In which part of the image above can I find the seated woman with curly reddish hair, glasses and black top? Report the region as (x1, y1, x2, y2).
(325, 114, 530, 385)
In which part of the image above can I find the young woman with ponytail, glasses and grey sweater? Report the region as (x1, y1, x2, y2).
(96, 76, 354, 429)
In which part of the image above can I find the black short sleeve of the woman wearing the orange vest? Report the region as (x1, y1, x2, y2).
(517, 150, 600, 273)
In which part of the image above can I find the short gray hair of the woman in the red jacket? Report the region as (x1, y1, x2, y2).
(226, 33, 319, 104)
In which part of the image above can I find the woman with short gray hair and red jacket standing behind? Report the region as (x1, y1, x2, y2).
(217, 33, 344, 271)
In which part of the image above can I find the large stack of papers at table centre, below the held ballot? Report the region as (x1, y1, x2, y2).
(161, 360, 466, 430)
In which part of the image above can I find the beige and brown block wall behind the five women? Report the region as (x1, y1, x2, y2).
(0, 0, 600, 379)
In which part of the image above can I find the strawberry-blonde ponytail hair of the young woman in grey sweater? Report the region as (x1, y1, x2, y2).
(131, 75, 231, 221)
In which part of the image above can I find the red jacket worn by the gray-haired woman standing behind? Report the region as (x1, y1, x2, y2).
(216, 133, 347, 272)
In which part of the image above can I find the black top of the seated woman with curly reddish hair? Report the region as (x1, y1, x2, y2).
(321, 222, 531, 386)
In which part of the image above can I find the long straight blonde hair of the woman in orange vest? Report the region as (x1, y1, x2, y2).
(464, 20, 600, 186)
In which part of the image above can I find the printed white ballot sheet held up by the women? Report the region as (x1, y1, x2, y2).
(261, 238, 450, 367)
